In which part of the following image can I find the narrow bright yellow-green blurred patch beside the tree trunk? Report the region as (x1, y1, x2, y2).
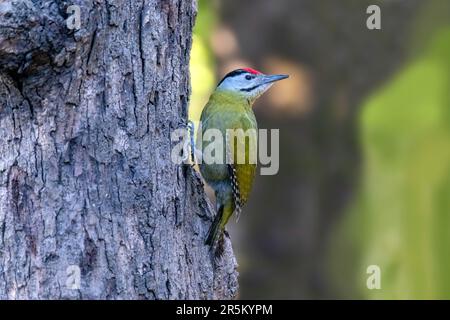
(189, 0, 217, 121)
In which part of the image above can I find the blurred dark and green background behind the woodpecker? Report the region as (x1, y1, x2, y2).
(189, 0, 450, 299)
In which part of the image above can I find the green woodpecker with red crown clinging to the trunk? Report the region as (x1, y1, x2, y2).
(198, 68, 288, 246)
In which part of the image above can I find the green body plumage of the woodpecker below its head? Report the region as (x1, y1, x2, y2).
(197, 90, 257, 245)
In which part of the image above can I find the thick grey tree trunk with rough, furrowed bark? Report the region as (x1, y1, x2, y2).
(0, 0, 237, 299)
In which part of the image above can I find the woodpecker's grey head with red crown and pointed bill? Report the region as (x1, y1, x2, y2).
(216, 68, 289, 101)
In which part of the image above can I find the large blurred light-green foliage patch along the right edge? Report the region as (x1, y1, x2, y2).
(336, 29, 450, 299)
